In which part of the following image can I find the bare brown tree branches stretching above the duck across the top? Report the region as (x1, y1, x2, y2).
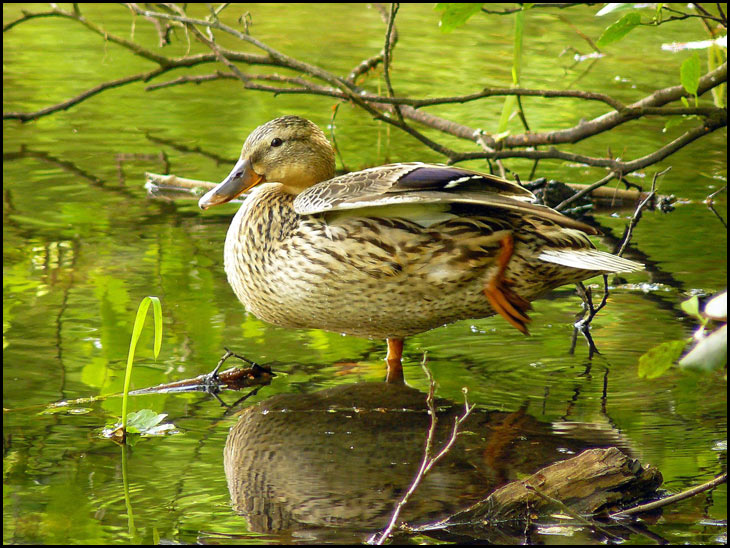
(3, 4, 727, 199)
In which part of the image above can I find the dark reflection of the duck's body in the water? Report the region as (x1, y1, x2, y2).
(224, 383, 621, 533)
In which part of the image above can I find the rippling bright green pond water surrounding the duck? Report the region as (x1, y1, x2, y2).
(3, 4, 727, 544)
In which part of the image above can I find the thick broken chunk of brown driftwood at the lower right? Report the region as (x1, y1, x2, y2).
(427, 447, 662, 529)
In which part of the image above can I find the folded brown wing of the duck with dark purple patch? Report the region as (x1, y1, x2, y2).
(294, 162, 599, 234)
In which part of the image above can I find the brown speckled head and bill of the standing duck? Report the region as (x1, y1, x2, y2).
(198, 116, 335, 209)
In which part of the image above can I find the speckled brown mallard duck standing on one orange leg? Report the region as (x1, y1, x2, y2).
(198, 115, 643, 384)
